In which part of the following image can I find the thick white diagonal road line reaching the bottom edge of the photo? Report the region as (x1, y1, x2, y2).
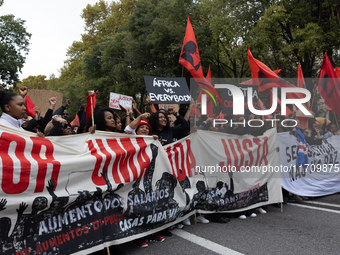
(171, 229, 243, 255)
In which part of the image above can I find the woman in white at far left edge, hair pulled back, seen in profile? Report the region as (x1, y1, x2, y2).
(0, 86, 28, 129)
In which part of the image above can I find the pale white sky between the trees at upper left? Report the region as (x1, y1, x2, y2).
(0, 0, 99, 80)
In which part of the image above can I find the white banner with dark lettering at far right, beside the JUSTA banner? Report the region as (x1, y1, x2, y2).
(278, 132, 340, 197)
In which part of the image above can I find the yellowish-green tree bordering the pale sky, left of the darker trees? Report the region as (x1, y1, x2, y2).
(58, 0, 134, 117)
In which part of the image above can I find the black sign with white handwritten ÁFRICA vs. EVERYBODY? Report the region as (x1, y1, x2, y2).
(144, 76, 191, 104)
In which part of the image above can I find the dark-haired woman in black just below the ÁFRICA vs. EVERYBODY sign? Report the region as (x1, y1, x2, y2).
(149, 107, 190, 145)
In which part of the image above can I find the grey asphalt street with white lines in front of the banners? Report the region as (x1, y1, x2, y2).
(107, 193, 340, 255)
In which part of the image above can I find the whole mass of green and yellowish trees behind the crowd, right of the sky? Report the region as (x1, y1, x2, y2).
(56, 0, 340, 117)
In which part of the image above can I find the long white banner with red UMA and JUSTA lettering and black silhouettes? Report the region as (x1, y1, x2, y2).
(0, 126, 282, 255)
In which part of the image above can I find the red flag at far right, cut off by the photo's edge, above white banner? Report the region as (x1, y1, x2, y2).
(317, 54, 340, 116)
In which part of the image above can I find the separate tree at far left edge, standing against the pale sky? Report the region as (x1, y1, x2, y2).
(0, 1, 31, 87)
